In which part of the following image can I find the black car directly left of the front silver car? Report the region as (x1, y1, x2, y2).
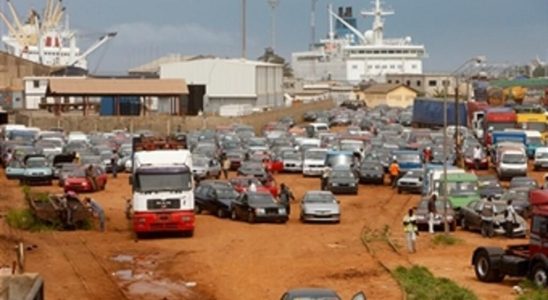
(230, 192, 289, 223)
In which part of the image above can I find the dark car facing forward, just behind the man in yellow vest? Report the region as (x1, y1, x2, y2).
(415, 198, 457, 231)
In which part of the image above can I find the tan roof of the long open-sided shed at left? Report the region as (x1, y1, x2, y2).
(47, 78, 188, 96)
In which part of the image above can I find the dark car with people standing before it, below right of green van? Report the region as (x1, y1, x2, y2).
(460, 200, 527, 237)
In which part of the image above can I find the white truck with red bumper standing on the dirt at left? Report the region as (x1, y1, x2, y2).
(130, 137, 195, 237)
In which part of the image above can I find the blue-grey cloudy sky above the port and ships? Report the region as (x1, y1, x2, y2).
(0, 0, 548, 74)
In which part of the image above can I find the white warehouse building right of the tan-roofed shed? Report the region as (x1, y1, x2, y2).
(160, 58, 284, 113)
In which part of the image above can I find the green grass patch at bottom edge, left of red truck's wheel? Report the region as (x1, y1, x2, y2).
(394, 266, 478, 300)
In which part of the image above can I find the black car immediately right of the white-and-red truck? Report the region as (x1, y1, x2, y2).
(194, 180, 238, 218)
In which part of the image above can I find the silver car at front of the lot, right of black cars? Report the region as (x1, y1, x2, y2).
(300, 191, 341, 223)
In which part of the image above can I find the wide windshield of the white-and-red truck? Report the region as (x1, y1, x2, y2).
(136, 172, 192, 193)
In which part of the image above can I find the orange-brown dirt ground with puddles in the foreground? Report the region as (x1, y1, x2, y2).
(0, 165, 542, 299)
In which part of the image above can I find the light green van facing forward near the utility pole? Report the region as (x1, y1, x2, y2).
(438, 173, 480, 210)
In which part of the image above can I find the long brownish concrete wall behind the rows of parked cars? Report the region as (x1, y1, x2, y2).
(15, 100, 335, 134)
